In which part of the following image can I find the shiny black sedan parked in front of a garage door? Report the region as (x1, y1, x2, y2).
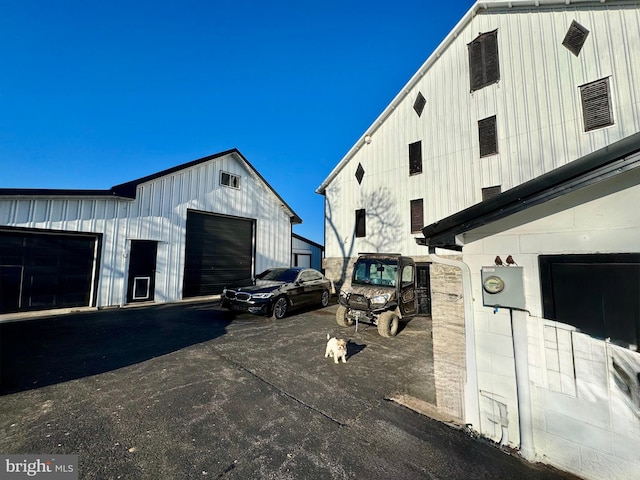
(220, 268, 331, 319)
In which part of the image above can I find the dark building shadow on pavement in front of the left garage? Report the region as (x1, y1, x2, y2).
(0, 303, 231, 395)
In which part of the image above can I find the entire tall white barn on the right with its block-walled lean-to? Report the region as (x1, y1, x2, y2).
(317, 0, 640, 479)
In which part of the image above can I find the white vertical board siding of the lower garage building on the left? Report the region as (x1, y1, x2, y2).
(0, 154, 291, 307)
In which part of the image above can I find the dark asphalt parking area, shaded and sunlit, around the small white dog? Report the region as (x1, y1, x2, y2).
(0, 302, 569, 479)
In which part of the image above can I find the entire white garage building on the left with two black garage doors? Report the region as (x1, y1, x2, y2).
(0, 149, 301, 314)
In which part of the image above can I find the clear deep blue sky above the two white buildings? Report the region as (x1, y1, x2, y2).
(0, 0, 474, 243)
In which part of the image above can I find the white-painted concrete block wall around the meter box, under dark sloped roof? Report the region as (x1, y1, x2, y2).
(463, 178, 640, 480)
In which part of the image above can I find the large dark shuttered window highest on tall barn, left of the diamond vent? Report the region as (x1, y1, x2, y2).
(467, 30, 500, 92)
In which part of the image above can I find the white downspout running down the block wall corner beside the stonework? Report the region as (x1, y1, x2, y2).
(429, 246, 480, 432)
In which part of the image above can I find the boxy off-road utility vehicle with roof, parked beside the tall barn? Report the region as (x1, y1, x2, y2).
(336, 253, 418, 337)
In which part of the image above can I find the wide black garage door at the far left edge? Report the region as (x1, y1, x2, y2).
(0, 230, 98, 313)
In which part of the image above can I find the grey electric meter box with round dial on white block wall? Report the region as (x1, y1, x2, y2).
(482, 266, 525, 310)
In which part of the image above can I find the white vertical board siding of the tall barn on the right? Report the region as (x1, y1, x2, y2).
(324, 2, 640, 258)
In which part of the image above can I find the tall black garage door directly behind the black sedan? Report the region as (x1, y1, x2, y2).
(184, 211, 254, 298)
